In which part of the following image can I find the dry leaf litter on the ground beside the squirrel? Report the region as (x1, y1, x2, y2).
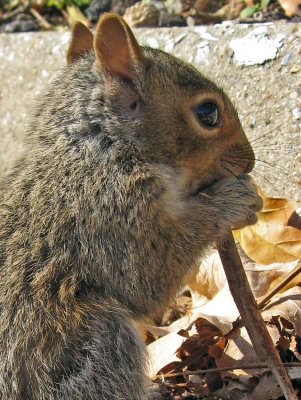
(144, 194, 301, 400)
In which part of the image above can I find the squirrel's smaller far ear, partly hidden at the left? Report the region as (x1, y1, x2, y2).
(67, 22, 93, 64)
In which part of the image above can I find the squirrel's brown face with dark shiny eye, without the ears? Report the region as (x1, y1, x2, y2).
(129, 49, 254, 193)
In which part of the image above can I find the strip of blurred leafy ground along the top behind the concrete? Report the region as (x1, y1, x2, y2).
(0, 0, 301, 33)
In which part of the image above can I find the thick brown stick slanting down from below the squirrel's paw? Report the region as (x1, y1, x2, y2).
(218, 230, 297, 400)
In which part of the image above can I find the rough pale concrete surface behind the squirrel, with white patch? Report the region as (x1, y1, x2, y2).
(0, 22, 301, 200)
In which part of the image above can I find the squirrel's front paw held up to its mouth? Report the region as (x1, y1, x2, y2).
(210, 174, 263, 229)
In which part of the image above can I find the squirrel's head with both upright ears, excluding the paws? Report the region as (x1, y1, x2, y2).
(67, 14, 254, 193)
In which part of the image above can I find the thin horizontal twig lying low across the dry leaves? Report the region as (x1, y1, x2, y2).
(154, 362, 301, 379)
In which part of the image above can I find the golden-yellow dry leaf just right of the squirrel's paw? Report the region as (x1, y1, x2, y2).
(233, 193, 301, 265)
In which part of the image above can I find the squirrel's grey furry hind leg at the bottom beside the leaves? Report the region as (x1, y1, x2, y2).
(57, 308, 149, 400)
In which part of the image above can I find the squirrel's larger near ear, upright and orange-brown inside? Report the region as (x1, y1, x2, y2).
(94, 14, 143, 79)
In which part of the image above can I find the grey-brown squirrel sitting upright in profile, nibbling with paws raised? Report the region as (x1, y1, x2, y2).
(0, 14, 262, 400)
